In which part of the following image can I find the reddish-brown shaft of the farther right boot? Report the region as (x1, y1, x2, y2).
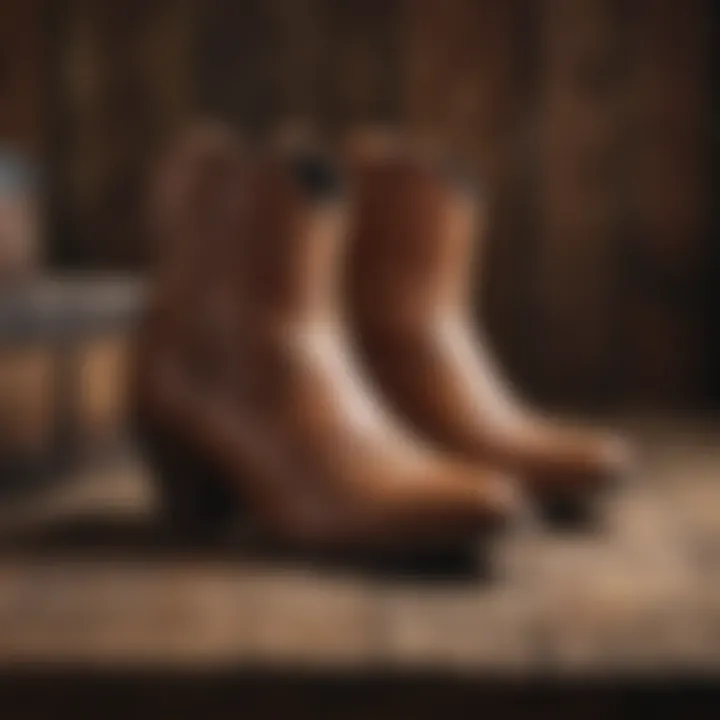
(349, 138, 483, 327)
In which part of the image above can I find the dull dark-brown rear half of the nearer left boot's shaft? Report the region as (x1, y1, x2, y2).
(140, 123, 246, 390)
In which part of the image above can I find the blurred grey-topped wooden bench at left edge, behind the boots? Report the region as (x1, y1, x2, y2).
(0, 277, 142, 494)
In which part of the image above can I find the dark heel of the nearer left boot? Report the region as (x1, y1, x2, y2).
(140, 428, 242, 540)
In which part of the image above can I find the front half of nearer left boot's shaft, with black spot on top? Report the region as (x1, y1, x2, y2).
(239, 149, 347, 327)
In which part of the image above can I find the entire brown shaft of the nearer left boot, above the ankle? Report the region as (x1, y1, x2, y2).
(141, 127, 354, 416)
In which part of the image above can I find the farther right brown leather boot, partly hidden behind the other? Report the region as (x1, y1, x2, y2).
(347, 132, 628, 513)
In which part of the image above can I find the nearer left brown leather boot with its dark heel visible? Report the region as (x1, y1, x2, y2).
(131, 124, 521, 548)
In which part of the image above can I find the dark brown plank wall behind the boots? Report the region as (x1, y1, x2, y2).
(0, 0, 718, 407)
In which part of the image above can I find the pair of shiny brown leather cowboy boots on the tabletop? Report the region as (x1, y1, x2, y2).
(134, 127, 627, 550)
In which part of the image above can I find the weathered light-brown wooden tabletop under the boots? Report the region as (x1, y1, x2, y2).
(0, 423, 720, 675)
